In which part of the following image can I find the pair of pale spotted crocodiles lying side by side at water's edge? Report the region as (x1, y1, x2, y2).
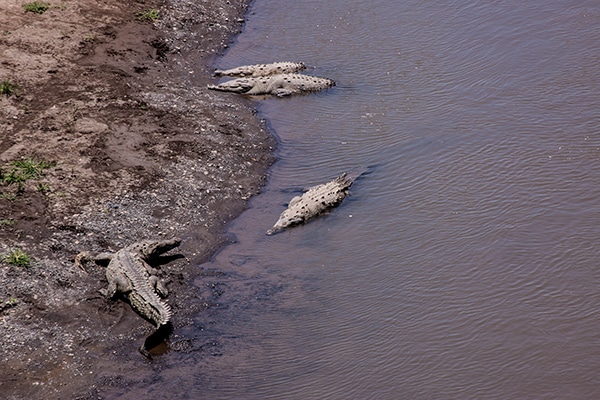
(208, 62, 335, 97)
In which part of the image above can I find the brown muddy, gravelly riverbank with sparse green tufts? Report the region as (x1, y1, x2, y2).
(0, 0, 275, 399)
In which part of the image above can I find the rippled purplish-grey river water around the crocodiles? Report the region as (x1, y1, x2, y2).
(196, 0, 600, 399)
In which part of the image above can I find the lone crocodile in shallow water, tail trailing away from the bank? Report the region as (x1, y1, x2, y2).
(267, 168, 365, 235)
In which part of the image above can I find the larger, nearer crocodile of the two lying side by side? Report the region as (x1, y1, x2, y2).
(208, 74, 335, 97)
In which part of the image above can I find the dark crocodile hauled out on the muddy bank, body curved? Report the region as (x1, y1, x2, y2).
(75, 238, 181, 356)
